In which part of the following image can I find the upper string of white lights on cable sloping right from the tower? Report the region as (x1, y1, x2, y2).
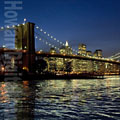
(35, 26, 78, 53)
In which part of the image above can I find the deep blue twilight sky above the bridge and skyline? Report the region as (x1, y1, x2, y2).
(0, 0, 120, 56)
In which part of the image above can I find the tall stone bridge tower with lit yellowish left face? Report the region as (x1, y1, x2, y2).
(15, 22, 35, 72)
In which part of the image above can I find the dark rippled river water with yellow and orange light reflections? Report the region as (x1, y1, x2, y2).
(0, 76, 120, 120)
